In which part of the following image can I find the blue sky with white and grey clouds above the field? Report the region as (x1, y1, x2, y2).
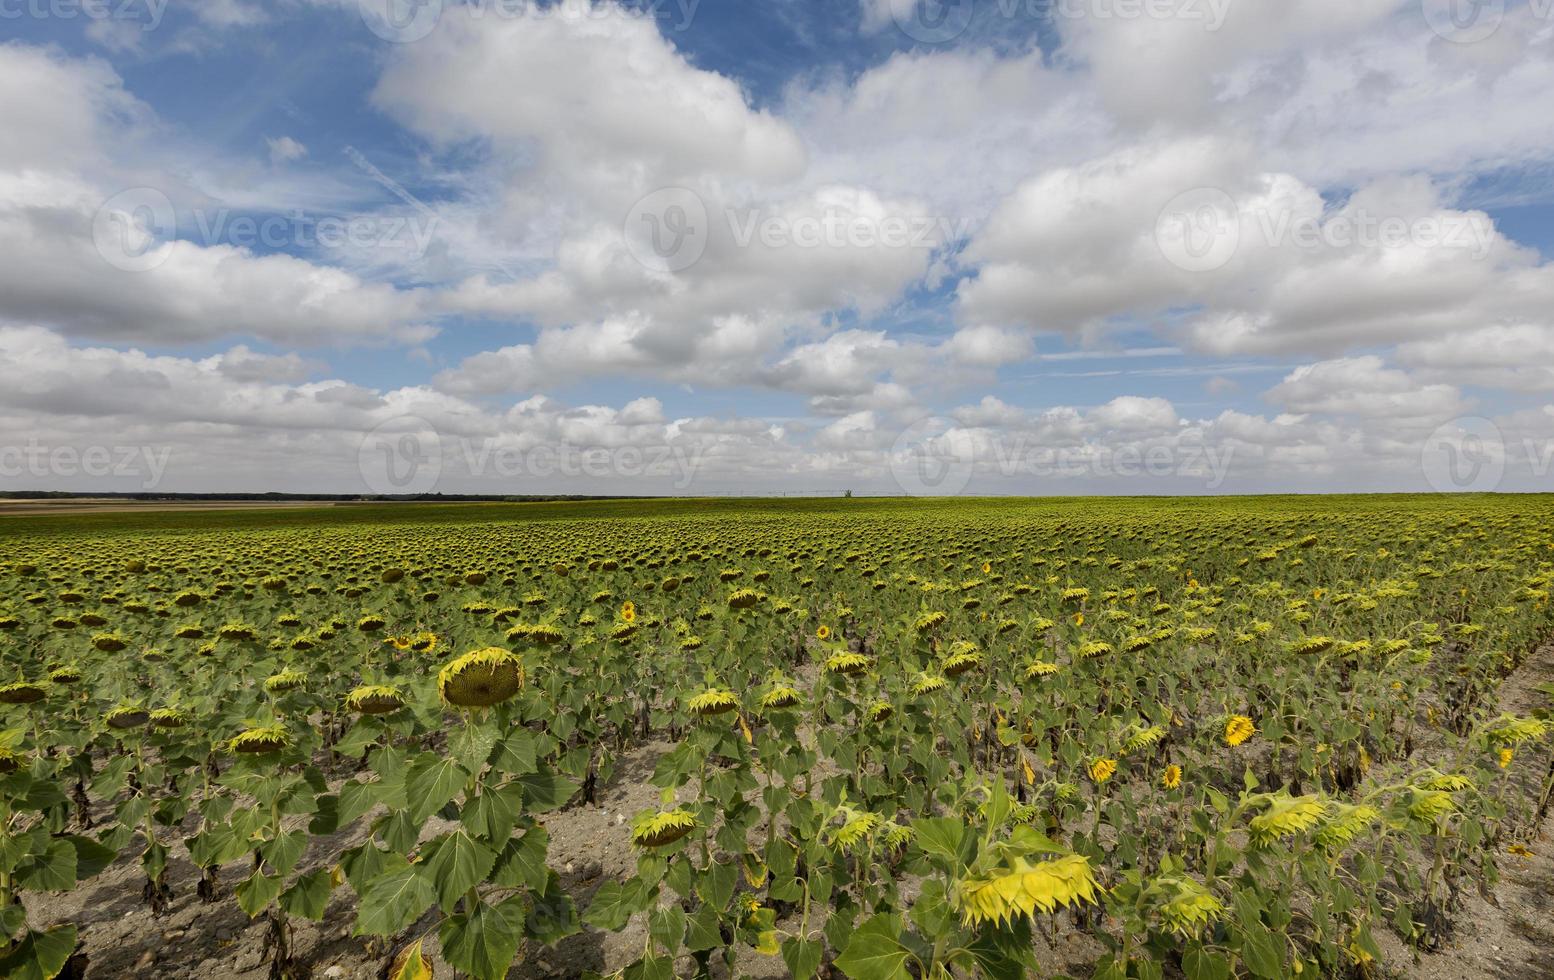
(0, 0, 1554, 495)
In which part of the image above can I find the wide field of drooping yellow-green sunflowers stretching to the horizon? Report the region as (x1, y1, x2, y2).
(0, 497, 1554, 980)
